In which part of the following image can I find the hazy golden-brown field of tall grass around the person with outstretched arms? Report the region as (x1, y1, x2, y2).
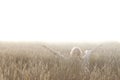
(0, 42, 120, 80)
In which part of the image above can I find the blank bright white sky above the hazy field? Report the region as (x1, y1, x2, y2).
(0, 0, 120, 42)
